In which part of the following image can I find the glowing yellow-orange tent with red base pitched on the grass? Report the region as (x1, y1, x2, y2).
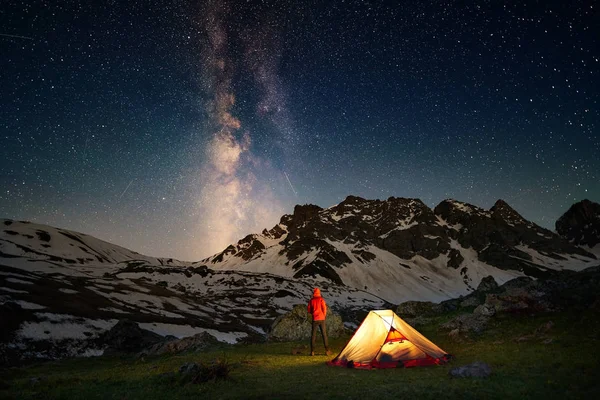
(327, 310, 450, 369)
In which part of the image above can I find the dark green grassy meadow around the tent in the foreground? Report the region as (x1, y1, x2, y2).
(0, 311, 600, 400)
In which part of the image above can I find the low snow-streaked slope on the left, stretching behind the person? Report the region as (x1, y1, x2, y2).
(0, 219, 386, 365)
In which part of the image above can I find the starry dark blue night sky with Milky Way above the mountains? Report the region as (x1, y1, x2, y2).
(0, 0, 600, 260)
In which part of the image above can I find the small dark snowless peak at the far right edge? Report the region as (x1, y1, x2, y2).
(556, 199, 600, 248)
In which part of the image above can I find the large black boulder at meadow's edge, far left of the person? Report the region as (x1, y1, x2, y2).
(99, 320, 164, 354)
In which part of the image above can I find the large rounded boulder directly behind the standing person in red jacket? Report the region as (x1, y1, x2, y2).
(268, 304, 344, 342)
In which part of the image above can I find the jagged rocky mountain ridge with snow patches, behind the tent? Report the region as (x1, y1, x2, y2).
(202, 196, 596, 303)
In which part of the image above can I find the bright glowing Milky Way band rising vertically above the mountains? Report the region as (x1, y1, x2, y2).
(196, 1, 284, 254)
